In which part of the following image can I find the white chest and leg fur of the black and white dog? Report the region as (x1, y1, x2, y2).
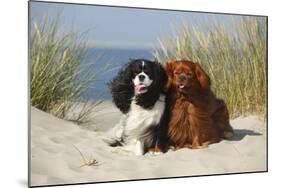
(106, 95, 165, 155)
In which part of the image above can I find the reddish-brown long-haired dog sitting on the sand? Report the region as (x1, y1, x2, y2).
(165, 61, 233, 149)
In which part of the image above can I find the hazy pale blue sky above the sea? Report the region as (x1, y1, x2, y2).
(30, 2, 264, 48)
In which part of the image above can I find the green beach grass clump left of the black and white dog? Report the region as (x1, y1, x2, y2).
(30, 16, 108, 124)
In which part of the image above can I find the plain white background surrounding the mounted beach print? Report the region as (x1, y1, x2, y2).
(0, 0, 281, 188)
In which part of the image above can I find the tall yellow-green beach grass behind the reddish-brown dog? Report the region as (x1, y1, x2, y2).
(154, 17, 267, 117)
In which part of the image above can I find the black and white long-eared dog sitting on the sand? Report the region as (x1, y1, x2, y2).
(104, 59, 168, 155)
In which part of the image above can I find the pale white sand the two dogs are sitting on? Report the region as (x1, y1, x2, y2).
(30, 102, 267, 186)
